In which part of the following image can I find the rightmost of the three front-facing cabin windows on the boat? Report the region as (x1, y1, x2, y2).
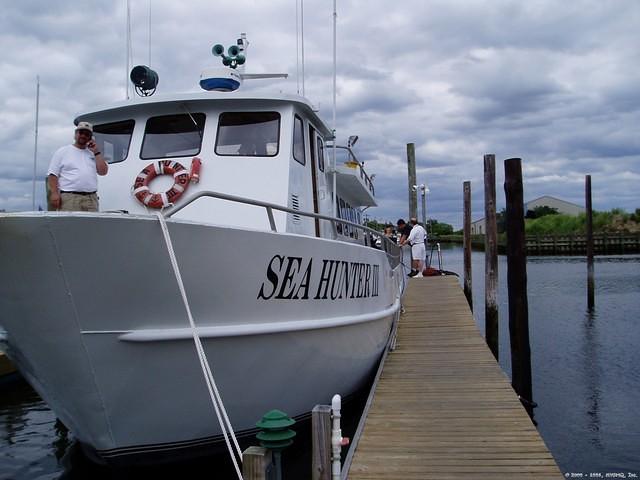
(216, 112, 280, 157)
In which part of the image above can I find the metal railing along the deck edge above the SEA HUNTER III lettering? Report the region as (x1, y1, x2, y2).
(162, 190, 400, 267)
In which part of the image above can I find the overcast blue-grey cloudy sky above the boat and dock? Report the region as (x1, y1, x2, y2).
(0, 0, 640, 227)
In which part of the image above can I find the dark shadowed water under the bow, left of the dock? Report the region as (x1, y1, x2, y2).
(0, 366, 369, 480)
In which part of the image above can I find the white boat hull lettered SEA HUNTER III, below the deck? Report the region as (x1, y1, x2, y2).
(0, 213, 401, 463)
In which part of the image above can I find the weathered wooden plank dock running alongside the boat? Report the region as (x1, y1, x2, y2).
(343, 277, 564, 480)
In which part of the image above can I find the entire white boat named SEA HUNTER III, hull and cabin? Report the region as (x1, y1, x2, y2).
(0, 32, 405, 465)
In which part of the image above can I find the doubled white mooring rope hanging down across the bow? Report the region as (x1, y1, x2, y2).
(156, 212, 243, 480)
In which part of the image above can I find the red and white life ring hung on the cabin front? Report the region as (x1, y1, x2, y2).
(133, 160, 189, 208)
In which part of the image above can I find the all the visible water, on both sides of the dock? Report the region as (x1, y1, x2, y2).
(0, 247, 640, 480)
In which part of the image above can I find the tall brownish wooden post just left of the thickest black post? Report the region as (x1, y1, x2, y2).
(484, 154, 500, 360)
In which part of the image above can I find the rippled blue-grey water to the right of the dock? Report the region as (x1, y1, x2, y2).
(443, 246, 640, 478)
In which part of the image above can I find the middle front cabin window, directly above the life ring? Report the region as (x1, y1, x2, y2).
(140, 113, 205, 160)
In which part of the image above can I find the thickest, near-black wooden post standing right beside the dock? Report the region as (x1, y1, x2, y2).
(504, 158, 535, 419)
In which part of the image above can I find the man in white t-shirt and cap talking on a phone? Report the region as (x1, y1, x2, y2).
(47, 122, 109, 212)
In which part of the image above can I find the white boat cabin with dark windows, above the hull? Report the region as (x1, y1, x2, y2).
(76, 92, 375, 243)
